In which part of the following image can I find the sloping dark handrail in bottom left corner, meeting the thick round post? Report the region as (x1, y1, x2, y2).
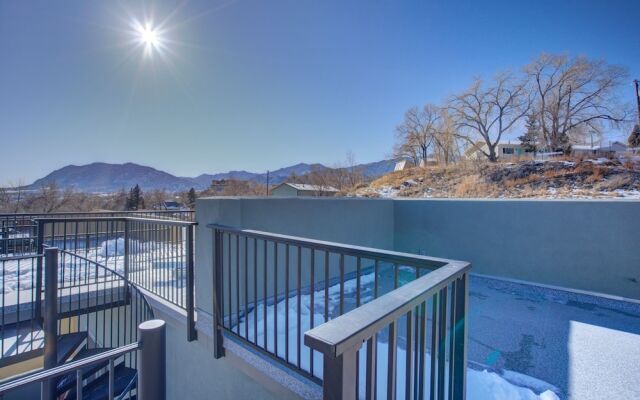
(0, 342, 140, 395)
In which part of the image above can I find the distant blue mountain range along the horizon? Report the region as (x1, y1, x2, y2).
(27, 160, 395, 193)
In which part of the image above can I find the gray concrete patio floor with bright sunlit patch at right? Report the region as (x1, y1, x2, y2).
(468, 276, 640, 400)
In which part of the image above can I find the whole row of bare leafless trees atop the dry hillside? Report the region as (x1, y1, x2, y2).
(394, 54, 633, 163)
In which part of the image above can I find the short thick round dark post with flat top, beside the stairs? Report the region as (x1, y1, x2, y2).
(138, 319, 167, 400)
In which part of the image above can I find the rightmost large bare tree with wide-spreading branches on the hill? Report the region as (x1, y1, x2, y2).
(525, 54, 627, 151)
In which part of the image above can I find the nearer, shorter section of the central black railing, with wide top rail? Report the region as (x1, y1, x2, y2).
(304, 262, 470, 400)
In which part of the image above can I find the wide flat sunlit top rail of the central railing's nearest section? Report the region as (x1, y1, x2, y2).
(304, 261, 471, 358)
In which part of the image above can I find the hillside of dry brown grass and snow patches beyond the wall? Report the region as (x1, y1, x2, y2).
(350, 158, 640, 199)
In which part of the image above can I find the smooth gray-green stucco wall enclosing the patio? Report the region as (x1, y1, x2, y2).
(196, 198, 640, 300)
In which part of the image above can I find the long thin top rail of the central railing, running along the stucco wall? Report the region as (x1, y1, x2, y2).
(207, 224, 456, 268)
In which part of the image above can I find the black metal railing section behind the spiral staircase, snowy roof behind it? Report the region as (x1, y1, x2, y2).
(36, 217, 196, 341)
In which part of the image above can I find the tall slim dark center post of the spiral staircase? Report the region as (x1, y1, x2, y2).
(42, 247, 58, 400)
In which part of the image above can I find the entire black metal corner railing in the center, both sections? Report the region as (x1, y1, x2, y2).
(209, 224, 470, 399)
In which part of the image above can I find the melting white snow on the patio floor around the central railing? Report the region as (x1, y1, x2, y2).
(233, 273, 558, 400)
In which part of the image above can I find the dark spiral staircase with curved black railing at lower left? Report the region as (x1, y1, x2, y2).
(0, 249, 153, 400)
